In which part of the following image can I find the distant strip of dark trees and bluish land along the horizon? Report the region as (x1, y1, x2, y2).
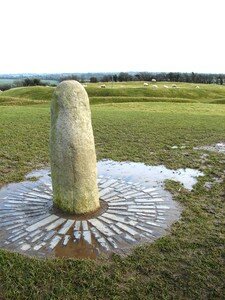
(0, 72, 225, 91)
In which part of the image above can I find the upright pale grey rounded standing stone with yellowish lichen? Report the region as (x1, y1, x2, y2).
(50, 80, 100, 214)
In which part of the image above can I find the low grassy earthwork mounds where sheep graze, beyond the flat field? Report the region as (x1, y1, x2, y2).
(0, 82, 225, 105)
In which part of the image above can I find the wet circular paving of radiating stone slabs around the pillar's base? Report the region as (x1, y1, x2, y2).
(0, 170, 180, 258)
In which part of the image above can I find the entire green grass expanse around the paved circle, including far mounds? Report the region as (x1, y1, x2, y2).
(0, 83, 225, 300)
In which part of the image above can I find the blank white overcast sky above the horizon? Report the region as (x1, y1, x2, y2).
(0, 0, 225, 73)
